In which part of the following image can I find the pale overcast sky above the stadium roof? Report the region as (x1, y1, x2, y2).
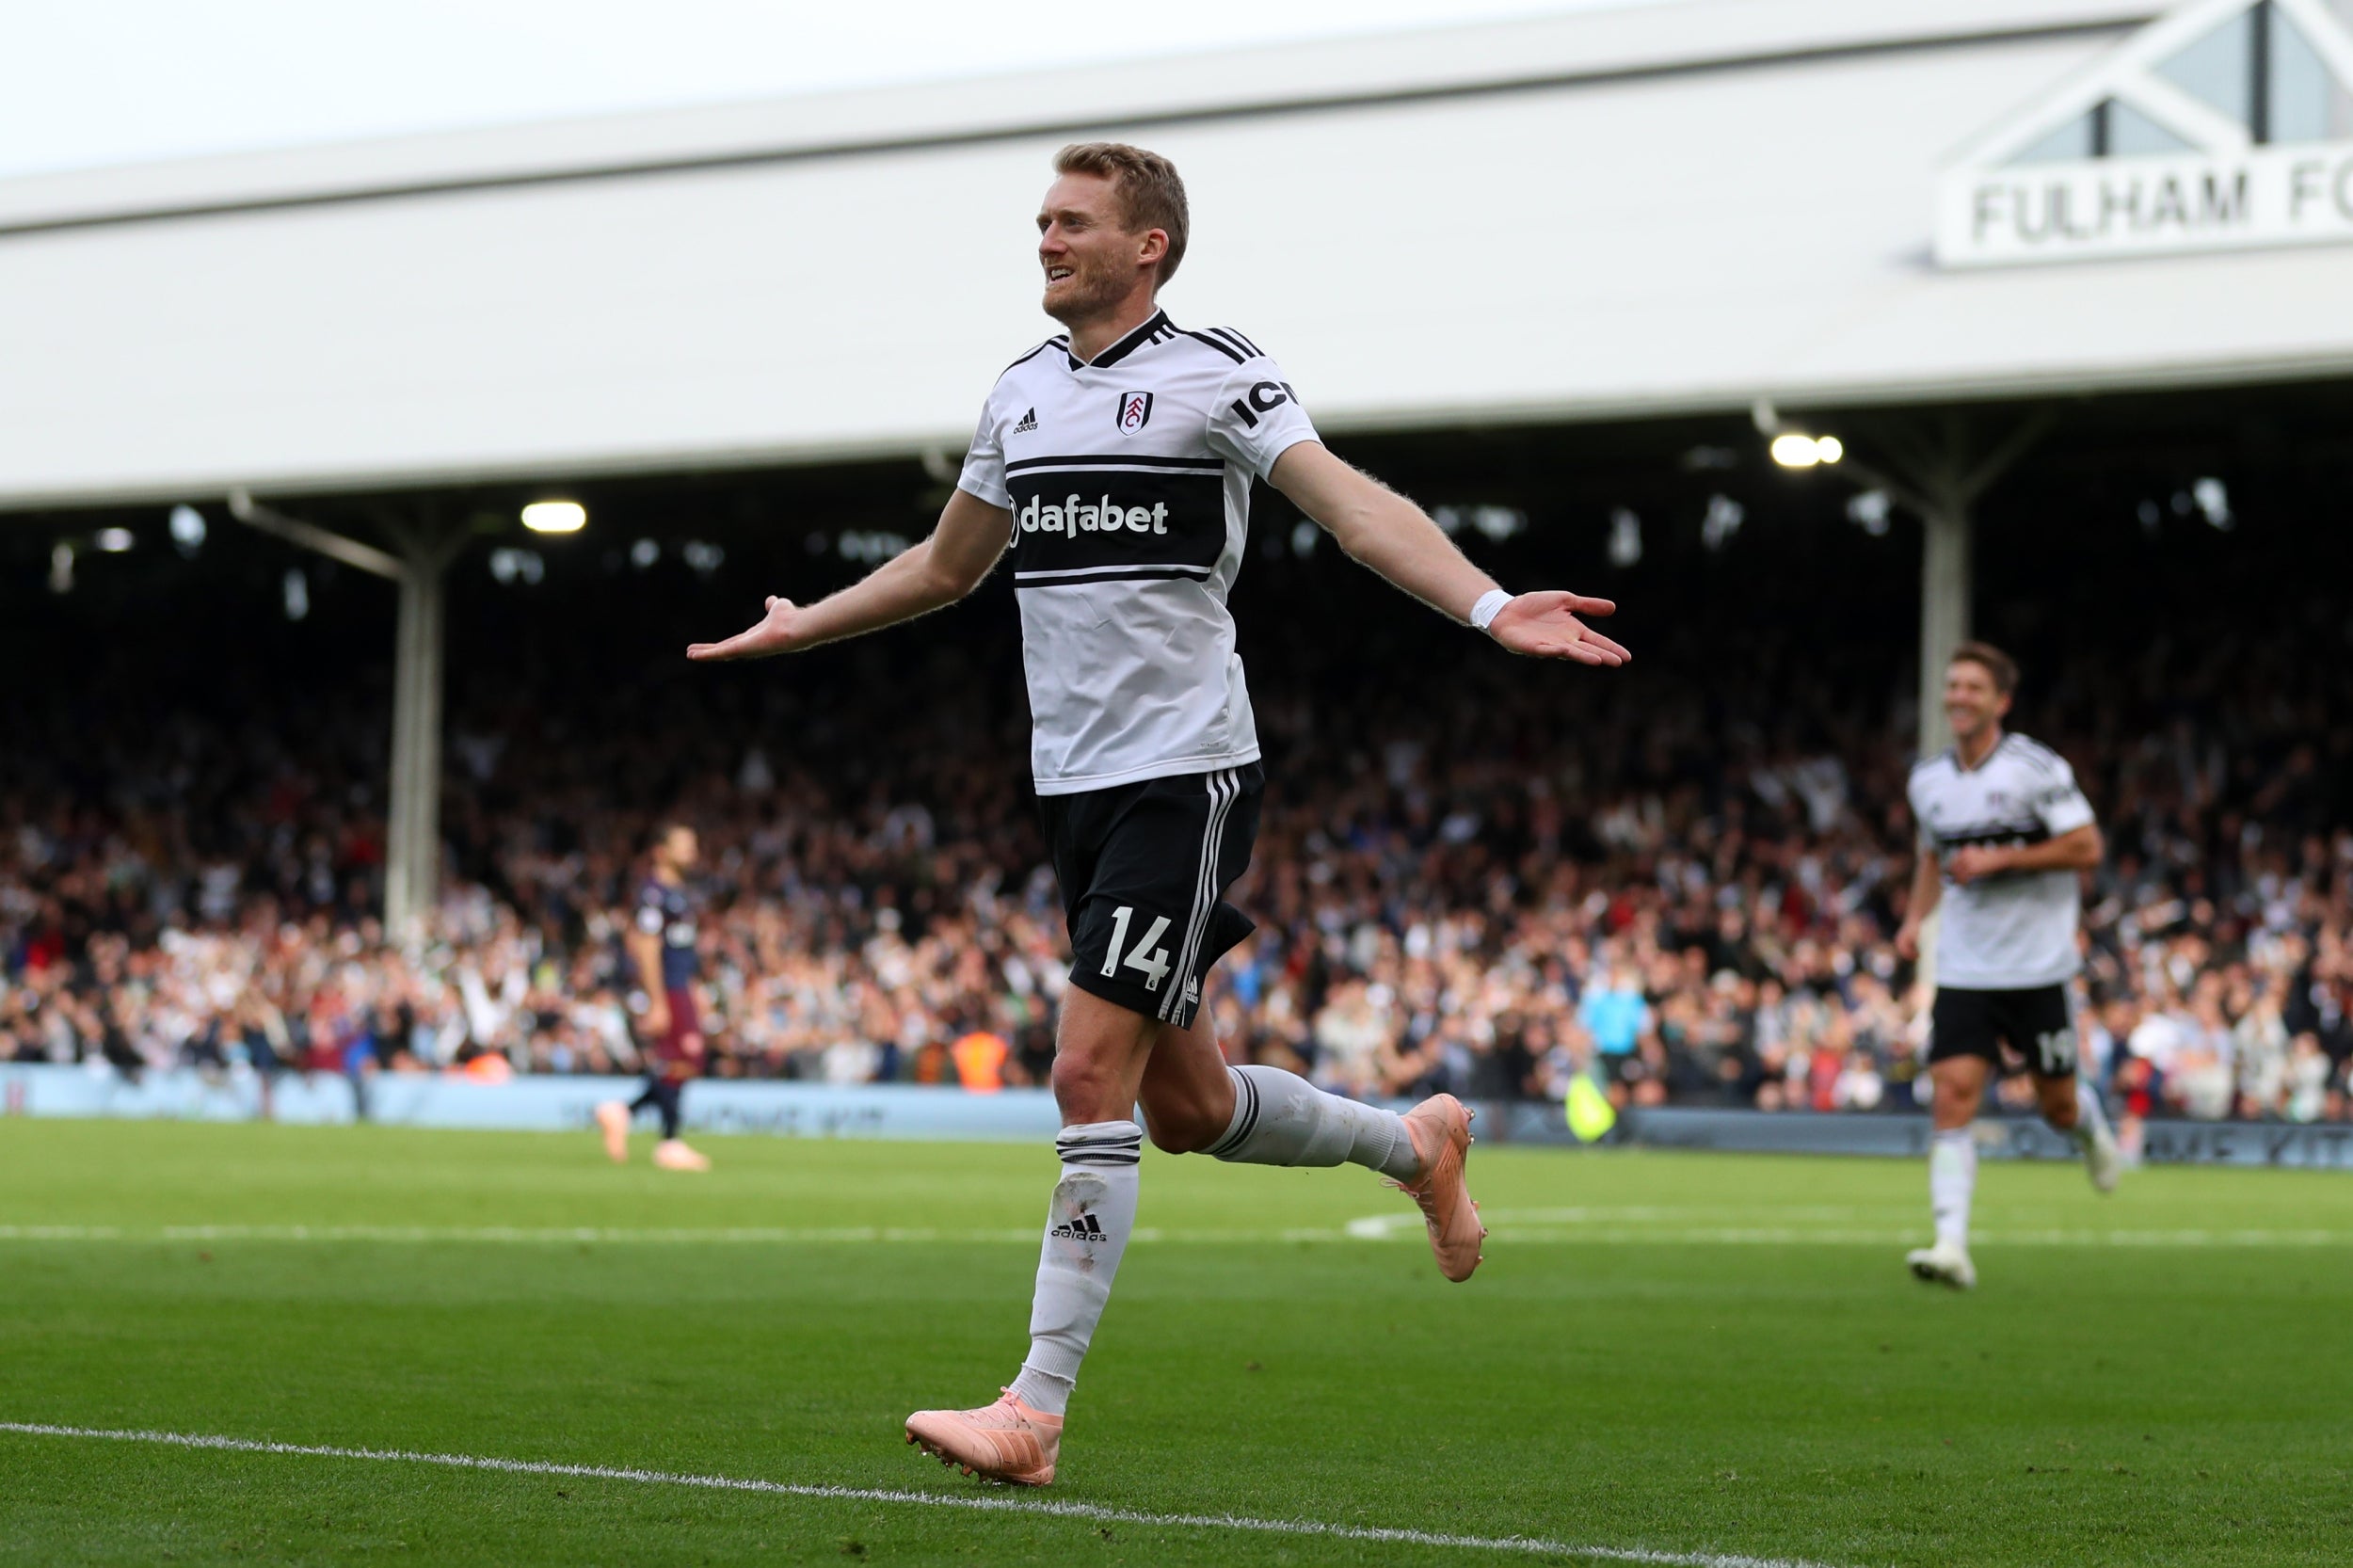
(0, 0, 1661, 179)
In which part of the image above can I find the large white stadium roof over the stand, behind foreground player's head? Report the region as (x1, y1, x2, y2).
(0, 0, 2353, 508)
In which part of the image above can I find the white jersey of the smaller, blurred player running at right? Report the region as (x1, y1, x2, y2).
(1906, 734, 2092, 991)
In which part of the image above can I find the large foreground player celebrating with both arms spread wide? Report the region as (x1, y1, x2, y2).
(687, 141, 1626, 1485)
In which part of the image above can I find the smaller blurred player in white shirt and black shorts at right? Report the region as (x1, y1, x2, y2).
(1897, 643, 2118, 1290)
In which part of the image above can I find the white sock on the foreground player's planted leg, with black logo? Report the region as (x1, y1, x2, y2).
(1012, 1121, 1144, 1415)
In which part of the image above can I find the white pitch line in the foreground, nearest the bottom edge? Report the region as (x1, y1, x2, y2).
(0, 1422, 1829, 1568)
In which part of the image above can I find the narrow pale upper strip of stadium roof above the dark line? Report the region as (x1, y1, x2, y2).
(0, 0, 2155, 235)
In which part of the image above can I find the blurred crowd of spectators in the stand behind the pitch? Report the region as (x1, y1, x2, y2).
(0, 557, 2353, 1121)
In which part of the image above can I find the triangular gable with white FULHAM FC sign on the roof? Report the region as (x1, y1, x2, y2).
(1937, 0, 2353, 266)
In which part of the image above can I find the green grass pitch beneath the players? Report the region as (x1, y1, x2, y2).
(0, 1121, 2353, 1568)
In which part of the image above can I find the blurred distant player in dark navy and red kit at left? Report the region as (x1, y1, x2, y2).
(596, 822, 711, 1170)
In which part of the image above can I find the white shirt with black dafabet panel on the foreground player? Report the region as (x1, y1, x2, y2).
(958, 311, 1316, 796)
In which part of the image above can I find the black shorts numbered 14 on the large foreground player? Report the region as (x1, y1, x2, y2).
(1038, 762, 1266, 1029)
